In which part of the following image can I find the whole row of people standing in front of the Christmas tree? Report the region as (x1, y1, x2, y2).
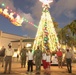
(0, 44, 73, 75)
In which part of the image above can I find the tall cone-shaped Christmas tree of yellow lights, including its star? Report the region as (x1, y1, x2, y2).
(33, 0, 59, 51)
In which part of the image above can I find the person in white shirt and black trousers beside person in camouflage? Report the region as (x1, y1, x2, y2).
(26, 50, 33, 74)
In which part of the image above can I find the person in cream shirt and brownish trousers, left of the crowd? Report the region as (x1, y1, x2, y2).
(4, 43, 14, 73)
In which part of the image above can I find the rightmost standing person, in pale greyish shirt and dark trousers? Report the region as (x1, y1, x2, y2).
(65, 49, 73, 73)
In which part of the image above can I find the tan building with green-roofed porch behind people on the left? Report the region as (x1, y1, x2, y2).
(0, 31, 34, 56)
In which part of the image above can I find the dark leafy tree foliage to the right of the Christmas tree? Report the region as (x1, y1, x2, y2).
(58, 20, 76, 46)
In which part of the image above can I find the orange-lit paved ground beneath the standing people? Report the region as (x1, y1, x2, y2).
(0, 63, 76, 75)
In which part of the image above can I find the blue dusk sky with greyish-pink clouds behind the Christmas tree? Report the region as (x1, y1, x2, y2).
(0, 0, 76, 37)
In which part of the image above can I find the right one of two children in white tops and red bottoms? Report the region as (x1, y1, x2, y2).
(46, 51, 51, 75)
